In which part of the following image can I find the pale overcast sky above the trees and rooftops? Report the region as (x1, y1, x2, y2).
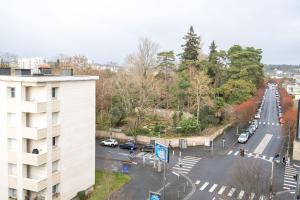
(0, 0, 300, 64)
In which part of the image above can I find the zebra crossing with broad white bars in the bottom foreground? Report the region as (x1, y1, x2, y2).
(195, 180, 267, 200)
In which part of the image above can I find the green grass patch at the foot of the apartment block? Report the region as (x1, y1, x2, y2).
(91, 170, 131, 200)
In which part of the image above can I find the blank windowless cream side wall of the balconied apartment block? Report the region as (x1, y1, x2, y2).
(58, 81, 95, 200)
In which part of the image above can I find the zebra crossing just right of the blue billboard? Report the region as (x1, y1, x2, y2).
(172, 156, 201, 174)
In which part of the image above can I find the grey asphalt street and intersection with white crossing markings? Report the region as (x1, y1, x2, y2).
(96, 85, 299, 200)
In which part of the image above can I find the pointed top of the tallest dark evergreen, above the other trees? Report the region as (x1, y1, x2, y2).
(180, 26, 201, 61)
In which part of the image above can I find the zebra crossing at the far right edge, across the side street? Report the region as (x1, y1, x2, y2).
(283, 165, 297, 194)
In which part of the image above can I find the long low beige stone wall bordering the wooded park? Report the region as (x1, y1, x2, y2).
(96, 124, 231, 147)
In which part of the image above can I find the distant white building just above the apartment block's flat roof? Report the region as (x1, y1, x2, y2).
(17, 57, 47, 73)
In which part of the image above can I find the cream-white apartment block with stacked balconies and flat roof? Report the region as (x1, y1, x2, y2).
(0, 69, 98, 200)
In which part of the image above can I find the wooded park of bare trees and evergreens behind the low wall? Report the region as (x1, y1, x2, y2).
(71, 26, 264, 138)
